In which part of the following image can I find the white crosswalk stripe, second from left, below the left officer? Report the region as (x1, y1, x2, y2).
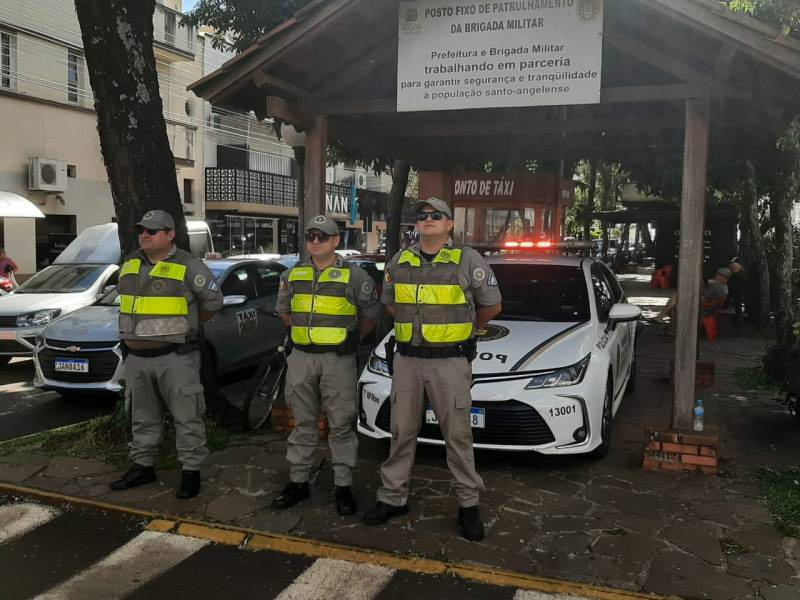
(36, 531, 208, 600)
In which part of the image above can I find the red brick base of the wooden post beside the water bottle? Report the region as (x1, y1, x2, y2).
(642, 428, 719, 474)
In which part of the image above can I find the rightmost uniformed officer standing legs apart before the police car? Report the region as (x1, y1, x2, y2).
(364, 198, 501, 541)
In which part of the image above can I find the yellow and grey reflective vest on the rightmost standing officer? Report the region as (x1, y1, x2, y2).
(394, 248, 475, 346)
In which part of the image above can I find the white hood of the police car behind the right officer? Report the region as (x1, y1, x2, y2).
(376, 320, 595, 374)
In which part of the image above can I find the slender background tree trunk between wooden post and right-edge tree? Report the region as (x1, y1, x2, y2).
(742, 161, 770, 329)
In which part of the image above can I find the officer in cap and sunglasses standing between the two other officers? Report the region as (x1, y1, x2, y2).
(272, 215, 381, 515)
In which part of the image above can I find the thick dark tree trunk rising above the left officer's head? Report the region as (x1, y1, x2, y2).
(75, 0, 189, 256)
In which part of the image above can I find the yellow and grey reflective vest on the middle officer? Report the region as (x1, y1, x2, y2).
(289, 265, 358, 346)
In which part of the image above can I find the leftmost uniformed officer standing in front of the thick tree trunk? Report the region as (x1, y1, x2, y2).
(111, 210, 222, 498)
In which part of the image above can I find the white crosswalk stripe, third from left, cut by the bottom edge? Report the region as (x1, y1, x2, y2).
(276, 558, 394, 600)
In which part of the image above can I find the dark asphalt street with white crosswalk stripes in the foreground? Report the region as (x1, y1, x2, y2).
(0, 494, 592, 600)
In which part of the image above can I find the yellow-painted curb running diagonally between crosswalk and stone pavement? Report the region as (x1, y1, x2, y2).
(0, 482, 676, 600)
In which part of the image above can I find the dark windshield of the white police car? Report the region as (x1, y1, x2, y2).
(492, 263, 589, 323)
